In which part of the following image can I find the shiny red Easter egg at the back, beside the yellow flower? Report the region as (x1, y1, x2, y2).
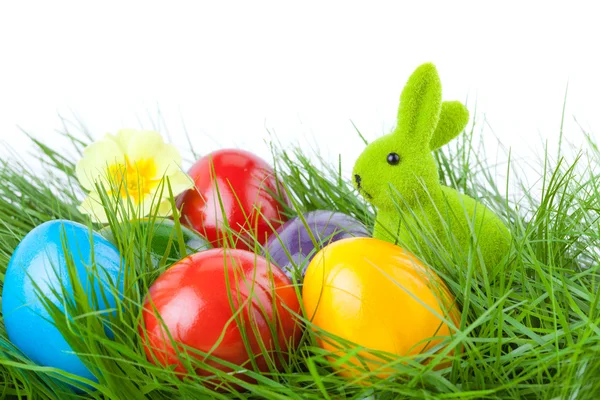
(177, 149, 289, 250)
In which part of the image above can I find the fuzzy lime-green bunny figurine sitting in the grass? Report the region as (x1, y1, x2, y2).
(353, 63, 511, 270)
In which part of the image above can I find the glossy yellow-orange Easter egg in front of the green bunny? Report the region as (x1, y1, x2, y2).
(302, 238, 459, 378)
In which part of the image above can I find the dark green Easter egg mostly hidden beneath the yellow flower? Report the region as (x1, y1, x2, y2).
(99, 218, 212, 265)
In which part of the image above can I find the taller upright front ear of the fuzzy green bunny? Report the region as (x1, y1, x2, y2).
(394, 63, 442, 149)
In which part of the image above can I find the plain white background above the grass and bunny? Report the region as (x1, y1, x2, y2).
(0, 1, 600, 182)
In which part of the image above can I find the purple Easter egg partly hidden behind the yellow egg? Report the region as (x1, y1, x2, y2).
(263, 210, 369, 282)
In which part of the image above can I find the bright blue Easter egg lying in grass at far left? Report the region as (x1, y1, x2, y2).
(2, 220, 123, 382)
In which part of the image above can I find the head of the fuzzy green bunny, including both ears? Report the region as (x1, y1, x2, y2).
(352, 63, 469, 209)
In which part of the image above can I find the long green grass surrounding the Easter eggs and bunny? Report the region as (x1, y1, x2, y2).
(0, 119, 600, 400)
